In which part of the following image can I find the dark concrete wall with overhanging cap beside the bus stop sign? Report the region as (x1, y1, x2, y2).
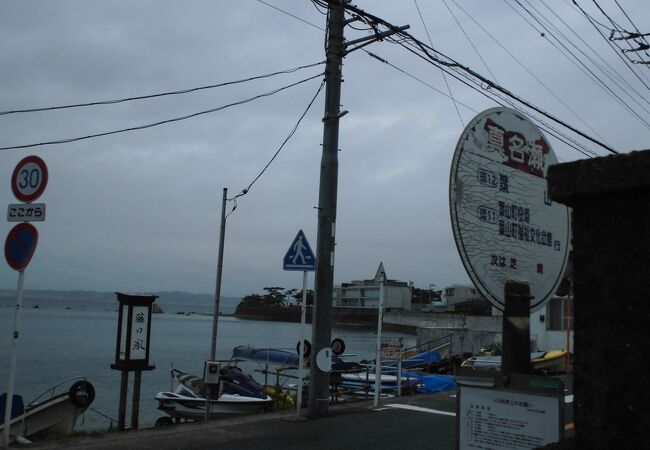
(548, 150, 650, 449)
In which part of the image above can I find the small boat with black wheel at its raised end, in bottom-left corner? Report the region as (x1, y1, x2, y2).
(0, 377, 95, 443)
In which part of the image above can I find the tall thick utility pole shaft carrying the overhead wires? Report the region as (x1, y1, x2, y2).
(309, 0, 345, 418)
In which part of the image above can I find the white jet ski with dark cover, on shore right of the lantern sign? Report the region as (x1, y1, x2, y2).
(155, 364, 273, 426)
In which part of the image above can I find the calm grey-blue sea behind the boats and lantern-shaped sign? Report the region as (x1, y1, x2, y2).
(0, 298, 415, 430)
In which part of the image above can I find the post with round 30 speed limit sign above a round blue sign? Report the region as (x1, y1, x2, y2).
(3, 156, 48, 448)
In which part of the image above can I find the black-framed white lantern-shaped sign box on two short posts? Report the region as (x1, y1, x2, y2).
(111, 292, 158, 371)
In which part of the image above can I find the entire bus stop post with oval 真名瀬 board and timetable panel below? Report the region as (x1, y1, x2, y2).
(449, 108, 570, 449)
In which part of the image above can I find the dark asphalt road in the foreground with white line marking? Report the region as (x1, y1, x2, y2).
(24, 392, 456, 450)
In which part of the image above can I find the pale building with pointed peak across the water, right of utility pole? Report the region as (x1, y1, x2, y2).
(333, 263, 411, 311)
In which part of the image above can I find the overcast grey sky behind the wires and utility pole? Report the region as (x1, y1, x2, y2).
(0, 0, 650, 296)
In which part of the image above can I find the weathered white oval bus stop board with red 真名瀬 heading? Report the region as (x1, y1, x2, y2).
(449, 108, 570, 310)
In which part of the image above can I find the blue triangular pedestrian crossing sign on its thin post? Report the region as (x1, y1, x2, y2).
(282, 230, 316, 417)
